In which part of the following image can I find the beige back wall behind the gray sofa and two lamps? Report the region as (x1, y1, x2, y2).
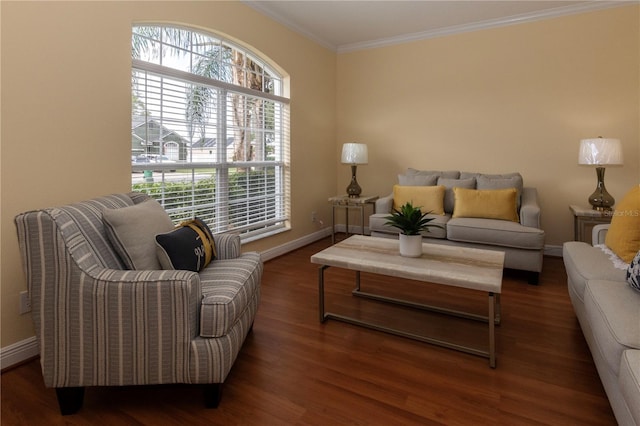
(336, 6, 640, 246)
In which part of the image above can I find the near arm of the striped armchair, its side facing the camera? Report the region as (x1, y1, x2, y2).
(38, 268, 202, 387)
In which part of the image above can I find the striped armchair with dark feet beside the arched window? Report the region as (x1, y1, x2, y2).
(15, 193, 262, 414)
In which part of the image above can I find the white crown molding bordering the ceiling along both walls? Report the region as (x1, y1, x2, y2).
(241, 0, 640, 53)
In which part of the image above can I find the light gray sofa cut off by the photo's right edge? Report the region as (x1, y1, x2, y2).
(563, 225, 640, 426)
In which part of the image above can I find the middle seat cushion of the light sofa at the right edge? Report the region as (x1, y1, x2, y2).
(584, 280, 640, 376)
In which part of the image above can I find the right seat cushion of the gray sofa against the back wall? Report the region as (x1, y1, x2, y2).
(447, 217, 544, 250)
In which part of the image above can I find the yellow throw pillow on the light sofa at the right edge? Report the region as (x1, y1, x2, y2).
(604, 185, 640, 263)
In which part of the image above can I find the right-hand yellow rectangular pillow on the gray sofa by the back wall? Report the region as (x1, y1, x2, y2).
(453, 188, 519, 222)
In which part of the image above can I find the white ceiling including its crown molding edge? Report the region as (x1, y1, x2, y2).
(243, 0, 638, 52)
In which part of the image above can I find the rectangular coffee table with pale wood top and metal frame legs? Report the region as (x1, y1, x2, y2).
(311, 235, 504, 368)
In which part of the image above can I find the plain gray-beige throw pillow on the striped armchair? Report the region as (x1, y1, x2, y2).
(102, 199, 174, 270)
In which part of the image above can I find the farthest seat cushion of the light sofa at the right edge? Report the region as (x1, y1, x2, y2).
(562, 241, 625, 302)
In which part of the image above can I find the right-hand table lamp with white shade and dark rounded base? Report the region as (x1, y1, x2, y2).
(578, 136, 622, 211)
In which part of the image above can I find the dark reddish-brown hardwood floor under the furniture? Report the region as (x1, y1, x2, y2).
(0, 239, 615, 426)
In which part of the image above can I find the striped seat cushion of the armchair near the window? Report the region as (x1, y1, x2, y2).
(199, 252, 262, 337)
